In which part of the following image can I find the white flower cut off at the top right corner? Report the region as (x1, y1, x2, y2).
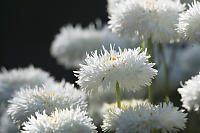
(177, 0, 200, 42)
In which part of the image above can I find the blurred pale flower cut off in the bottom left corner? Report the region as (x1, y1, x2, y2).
(0, 111, 19, 133)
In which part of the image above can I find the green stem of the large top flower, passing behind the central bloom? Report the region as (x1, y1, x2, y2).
(148, 38, 153, 103)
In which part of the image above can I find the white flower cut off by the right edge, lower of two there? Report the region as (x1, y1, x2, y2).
(178, 73, 200, 111)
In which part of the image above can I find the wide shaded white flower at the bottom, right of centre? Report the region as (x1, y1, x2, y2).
(102, 102, 187, 133)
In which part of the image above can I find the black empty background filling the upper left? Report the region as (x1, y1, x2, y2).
(0, 0, 108, 82)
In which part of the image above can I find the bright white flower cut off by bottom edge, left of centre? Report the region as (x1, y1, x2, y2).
(22, 108, 97, 133)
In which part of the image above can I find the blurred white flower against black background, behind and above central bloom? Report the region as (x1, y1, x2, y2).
(50, 24, 137, 68)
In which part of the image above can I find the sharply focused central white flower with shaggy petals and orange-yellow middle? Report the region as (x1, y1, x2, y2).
(75, 46, 157, 92)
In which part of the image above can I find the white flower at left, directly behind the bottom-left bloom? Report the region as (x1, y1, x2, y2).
(8, 83, 87, 125)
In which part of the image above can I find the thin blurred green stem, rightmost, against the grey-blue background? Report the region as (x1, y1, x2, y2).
(158, 43, 169, 101)
